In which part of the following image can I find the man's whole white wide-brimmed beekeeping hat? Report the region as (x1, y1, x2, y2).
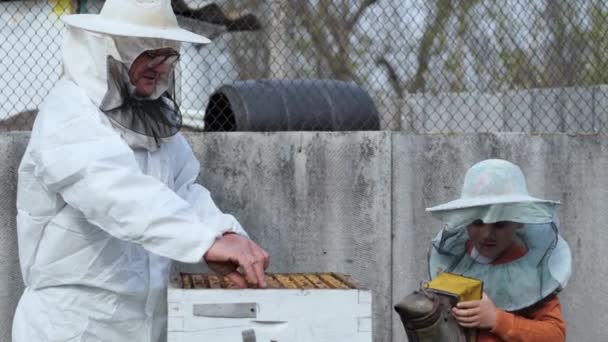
(62, 0, 211, 44)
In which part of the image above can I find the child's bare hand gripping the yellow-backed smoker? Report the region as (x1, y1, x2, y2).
(452, 292, 496, 329)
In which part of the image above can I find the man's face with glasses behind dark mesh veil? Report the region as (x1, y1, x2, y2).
(129, 48, 179, 97)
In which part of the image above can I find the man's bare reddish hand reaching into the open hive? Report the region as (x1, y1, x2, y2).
(203, 233, 270, 288)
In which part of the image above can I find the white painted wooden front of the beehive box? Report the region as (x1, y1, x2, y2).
(167, 288, 372, 342)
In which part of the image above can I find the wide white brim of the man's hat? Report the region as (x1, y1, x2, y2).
(62, 14, 211, 44)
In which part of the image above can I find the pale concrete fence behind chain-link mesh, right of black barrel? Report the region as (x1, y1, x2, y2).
(402, 85, 608, 133)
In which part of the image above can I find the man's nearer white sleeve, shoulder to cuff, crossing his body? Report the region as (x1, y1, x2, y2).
(29, 84, 221, 263)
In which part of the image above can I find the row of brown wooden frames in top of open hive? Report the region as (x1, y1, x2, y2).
(176, 273, 360, 290)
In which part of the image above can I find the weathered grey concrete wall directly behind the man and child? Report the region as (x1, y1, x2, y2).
(0, 132, 608, 342)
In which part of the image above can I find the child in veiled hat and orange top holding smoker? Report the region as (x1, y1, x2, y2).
(427, 159, 571, 342)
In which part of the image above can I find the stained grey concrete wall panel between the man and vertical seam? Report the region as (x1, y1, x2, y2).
(190, 132, 391, 342)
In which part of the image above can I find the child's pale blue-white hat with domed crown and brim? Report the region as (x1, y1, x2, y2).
(426, 159, 559, 212)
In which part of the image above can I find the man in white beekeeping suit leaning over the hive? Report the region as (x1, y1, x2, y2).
(12, 0, 269, 342)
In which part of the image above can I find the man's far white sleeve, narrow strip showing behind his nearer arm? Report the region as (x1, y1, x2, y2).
(171, 134, 248, 236)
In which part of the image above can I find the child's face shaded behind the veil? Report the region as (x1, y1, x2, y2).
(467, 220, 521, 259)
